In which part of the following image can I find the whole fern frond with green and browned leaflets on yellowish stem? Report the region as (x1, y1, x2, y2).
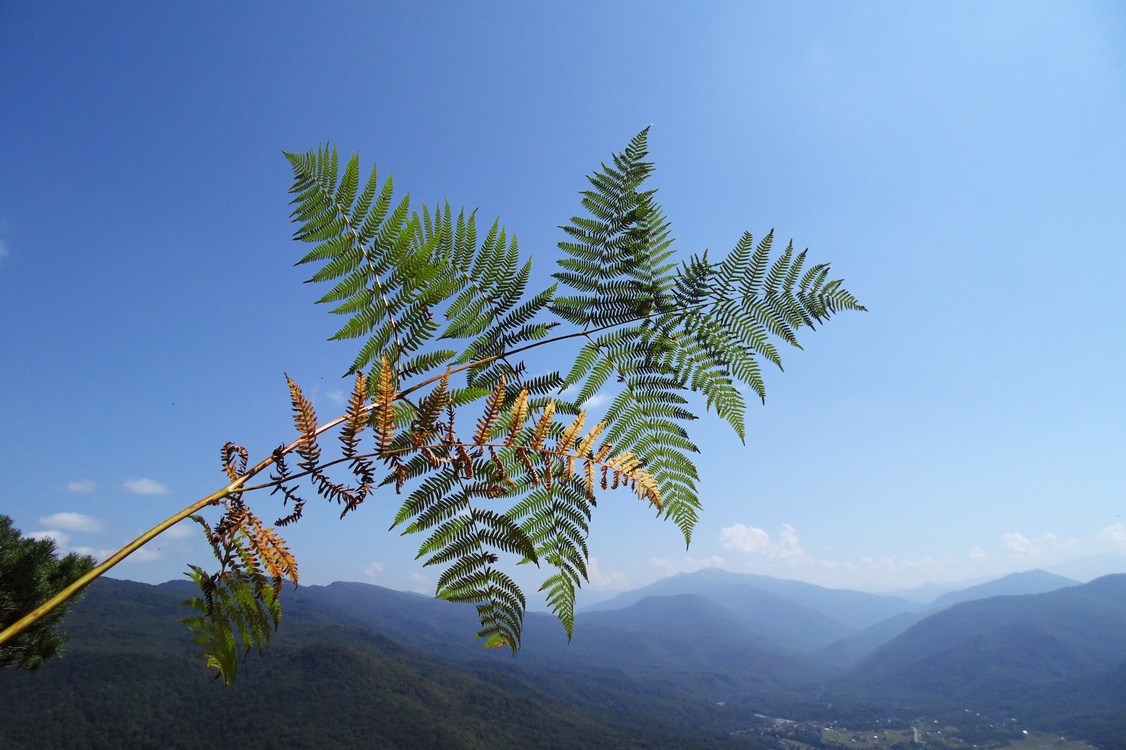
(0, 130, 864, 681)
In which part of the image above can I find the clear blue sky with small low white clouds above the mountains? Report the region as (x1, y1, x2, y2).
(0, 0, 1126, 600)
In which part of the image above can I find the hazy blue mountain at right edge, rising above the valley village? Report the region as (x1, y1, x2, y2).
(832, 574, 1126, 731)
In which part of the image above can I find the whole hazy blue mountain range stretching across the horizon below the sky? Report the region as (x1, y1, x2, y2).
(0, 571, 1126, 748)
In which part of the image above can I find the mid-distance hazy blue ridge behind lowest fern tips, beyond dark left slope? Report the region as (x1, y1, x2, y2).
(287, 583, 840, 697)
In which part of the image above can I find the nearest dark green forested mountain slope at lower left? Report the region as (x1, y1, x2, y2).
(0, 579, 717, 749)
